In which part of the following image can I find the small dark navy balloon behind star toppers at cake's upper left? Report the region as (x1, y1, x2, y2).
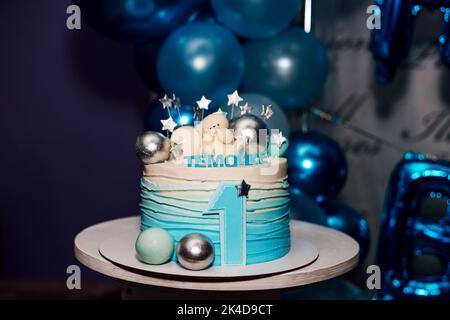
(144, 101, 194, 132)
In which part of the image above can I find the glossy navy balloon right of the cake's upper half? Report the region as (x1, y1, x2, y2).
(286, 131, 347, 202)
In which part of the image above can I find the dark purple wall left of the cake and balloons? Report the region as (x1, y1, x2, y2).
(0, 0, 148, 277)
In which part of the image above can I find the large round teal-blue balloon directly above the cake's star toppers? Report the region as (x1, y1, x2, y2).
(157, 22, 244, 104)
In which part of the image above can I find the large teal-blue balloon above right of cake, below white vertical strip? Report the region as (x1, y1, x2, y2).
(242, 28, 328, 109)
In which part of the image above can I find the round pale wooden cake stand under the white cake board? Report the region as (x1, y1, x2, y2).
(75, 217, 359, 299)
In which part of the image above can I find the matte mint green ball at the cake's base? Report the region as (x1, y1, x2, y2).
(136, 228, 174, 264)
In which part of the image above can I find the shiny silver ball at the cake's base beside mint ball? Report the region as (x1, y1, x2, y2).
(176, 233, 214, 271)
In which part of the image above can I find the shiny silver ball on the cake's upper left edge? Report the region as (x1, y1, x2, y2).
(135, 131, 170, 164)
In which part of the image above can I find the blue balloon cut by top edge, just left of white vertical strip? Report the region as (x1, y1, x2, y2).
(212, 0, 301, 38)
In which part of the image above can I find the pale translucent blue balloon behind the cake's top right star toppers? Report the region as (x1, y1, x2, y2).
(241, 93, 291, 138)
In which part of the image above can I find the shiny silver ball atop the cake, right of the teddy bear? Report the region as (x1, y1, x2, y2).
(229, 113, 269, 152)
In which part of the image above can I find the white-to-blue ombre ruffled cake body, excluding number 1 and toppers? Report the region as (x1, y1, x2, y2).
(140, 158, 290, 266)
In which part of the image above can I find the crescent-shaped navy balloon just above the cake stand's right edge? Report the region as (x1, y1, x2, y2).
(323, 203, 370, 264)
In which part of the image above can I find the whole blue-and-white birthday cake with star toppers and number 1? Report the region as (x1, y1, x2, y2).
(136, 92, 290, 266)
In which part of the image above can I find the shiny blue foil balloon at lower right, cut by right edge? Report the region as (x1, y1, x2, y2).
(376, 153, 450, 300)
